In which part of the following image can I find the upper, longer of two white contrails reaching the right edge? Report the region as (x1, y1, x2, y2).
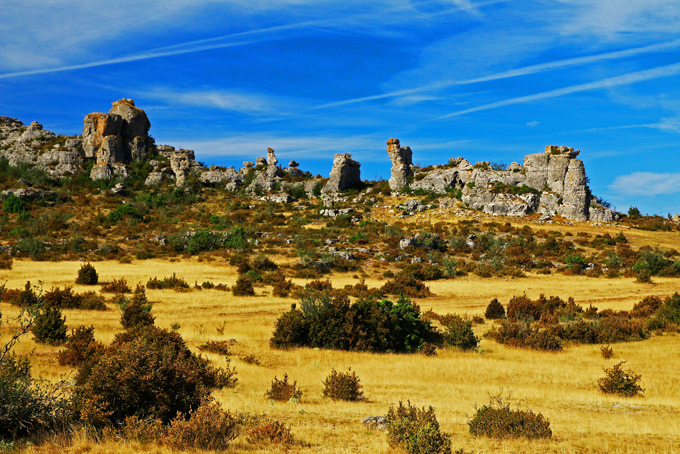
(314, 39, 680, 109)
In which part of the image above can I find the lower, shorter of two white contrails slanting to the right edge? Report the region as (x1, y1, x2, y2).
(435, 63, 680, 120)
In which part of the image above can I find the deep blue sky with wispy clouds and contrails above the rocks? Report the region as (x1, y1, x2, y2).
(0, 0, 680, 215)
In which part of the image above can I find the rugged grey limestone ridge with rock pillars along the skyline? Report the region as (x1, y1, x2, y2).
(0, 99, 619, 222)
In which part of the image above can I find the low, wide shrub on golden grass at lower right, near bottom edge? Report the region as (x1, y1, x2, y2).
(468, 394, 552, 438)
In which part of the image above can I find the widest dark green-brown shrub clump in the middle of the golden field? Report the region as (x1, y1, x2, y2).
(270, 289, 435, 353)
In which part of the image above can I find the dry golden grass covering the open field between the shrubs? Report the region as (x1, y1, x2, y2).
(0, 258, 680, 453)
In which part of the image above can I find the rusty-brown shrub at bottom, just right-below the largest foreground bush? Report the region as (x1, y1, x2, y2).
(162, 401, 239, 451)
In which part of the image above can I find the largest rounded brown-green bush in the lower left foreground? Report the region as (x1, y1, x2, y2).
(74, 326, 236, 427)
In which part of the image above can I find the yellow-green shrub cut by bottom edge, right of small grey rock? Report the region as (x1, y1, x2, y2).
(386, 402, 451, 454)
